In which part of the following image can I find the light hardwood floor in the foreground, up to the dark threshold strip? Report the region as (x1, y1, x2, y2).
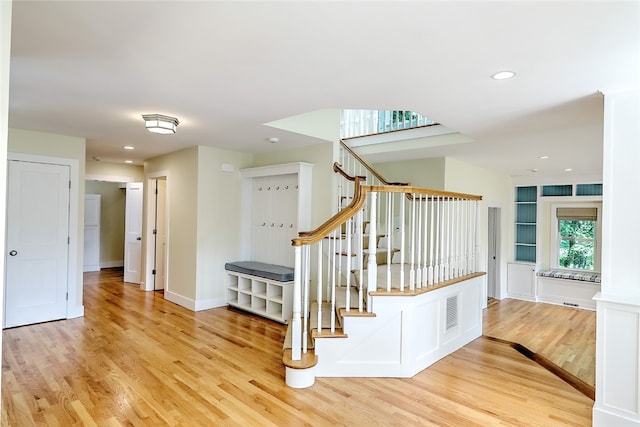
(2, 270, 593, 427)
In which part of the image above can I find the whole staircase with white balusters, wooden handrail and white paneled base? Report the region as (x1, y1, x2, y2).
(283, 143, 484, 388)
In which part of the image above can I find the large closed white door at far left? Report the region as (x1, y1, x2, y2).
(4, 161, 70, 327)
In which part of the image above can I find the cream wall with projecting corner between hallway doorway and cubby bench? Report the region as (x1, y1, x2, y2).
(143, 147, 252, 310)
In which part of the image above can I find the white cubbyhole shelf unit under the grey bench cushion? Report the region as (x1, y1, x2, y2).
(227, 271, 293, 323)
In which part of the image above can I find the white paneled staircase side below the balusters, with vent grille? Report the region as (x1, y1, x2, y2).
(287, 275, 486, 386)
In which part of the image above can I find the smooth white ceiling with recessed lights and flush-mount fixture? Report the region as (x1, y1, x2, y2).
(9, 0, 640, 175)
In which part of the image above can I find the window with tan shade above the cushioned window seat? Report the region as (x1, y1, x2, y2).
(555, 206, 600, 271)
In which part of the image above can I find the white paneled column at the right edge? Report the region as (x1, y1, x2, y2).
(593, 90, 640, 427)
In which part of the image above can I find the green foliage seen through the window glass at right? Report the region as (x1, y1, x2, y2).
(558, 220, 596, 270)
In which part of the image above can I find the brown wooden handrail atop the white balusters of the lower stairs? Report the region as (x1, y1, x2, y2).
(291, 182, 482, 246)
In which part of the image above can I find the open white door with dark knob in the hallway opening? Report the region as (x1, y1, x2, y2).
(124, 182, 143, 284)
